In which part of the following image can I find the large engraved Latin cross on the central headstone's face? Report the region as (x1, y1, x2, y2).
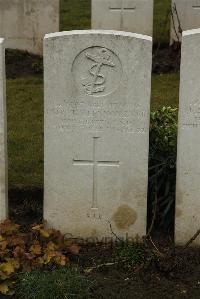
(73, 137, 120, 218)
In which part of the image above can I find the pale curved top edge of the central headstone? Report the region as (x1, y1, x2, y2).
(44, 30, 152, 42)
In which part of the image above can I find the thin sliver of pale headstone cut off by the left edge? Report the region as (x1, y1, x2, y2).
(0, 38, 8, 221)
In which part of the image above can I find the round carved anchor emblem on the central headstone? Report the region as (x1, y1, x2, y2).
(72, 47, 122, 97)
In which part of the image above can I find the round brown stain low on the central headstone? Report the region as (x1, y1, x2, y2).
(113, 204, 137, 229)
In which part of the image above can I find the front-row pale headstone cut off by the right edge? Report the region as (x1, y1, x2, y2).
(176, 29, 200, 245)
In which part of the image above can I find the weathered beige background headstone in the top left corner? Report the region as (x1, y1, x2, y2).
(0, 0, 59, 54)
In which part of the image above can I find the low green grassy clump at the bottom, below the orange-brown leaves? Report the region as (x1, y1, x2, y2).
(16, 267, 91, 299)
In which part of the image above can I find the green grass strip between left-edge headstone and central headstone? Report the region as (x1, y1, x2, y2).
(7, 77, 43, 189)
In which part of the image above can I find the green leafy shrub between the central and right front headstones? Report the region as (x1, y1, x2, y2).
(148, 107, 177, 231)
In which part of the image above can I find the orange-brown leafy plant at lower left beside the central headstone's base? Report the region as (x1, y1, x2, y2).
(0, 220, 80, 294)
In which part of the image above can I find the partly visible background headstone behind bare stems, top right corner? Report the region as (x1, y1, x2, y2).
(170, 0, 200, 44)
